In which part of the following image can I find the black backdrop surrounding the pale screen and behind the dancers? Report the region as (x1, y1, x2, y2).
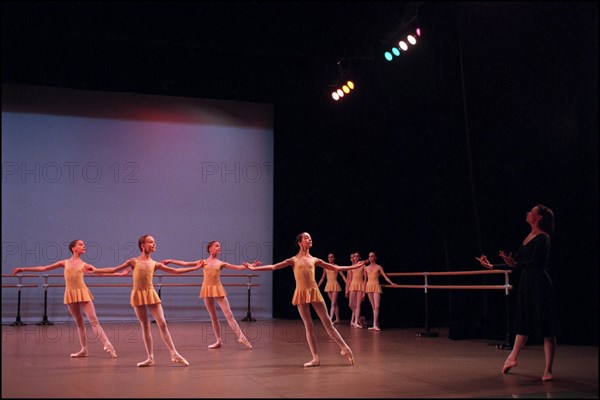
(2, 1, 599, 345)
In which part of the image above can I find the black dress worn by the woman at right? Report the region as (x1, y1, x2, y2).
(514, 233, 559, 337)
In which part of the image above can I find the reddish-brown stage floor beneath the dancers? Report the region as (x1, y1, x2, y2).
(2, 319, 598, 398)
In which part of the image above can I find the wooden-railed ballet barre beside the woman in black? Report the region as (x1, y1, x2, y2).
(381, 269, 512, 350)
